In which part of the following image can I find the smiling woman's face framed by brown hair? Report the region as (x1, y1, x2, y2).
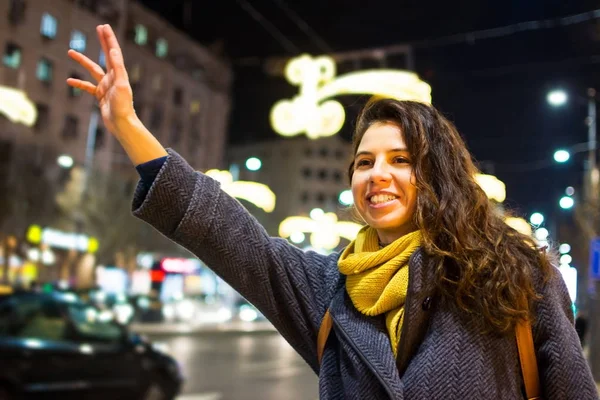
(352, 122, 417, 244)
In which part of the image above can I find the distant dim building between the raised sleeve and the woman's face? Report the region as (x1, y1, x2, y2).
(226, 135, 357, 247)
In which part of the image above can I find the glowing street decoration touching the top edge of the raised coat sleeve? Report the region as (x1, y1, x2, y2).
(205, 169, 276, 213)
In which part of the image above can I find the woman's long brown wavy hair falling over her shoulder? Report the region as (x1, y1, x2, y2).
(348, 99, 554, 334)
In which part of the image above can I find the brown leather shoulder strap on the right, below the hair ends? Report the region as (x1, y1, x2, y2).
(515, 321, 542, 400)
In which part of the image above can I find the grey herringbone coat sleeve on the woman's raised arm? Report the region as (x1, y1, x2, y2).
(132, 149, 338, 370)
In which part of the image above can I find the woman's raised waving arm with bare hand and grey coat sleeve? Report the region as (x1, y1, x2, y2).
(67, 25, 339, 371)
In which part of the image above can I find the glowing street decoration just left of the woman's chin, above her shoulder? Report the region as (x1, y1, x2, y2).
(279, 209, 362, 250)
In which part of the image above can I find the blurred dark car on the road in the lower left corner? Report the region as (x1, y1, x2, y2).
(0, 292, 183, 400)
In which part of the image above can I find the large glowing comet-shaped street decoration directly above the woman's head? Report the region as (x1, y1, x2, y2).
(271, 54, 431, 139)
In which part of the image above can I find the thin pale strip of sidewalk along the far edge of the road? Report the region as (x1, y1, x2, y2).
(129, 321, 277, 335)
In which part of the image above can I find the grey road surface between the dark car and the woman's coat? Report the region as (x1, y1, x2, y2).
(150, 332, 318, 400)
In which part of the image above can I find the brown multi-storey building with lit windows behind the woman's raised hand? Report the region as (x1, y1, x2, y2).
(0, 0, 232, 280)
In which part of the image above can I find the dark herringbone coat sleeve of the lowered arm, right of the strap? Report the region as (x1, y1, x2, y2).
(533, 268, 598, 400)
